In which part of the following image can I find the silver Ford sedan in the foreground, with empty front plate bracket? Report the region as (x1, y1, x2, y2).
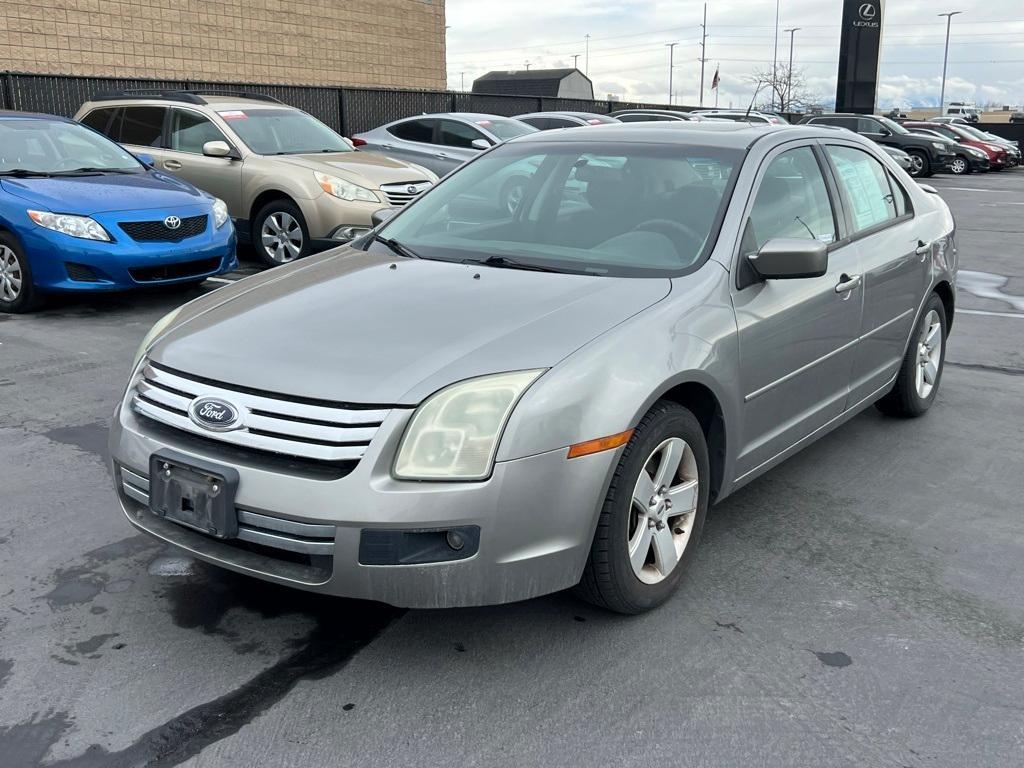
(111, 123, 957, 613)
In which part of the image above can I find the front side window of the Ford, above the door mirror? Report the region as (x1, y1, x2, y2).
(742, 146, 837, 253)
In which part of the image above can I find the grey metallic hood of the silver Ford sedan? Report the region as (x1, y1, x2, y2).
(150, 247, 672, 404)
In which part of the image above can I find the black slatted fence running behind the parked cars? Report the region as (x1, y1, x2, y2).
(0, 72, 695, 136)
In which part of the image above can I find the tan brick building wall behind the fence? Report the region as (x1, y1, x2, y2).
(0, 0, 446, 89)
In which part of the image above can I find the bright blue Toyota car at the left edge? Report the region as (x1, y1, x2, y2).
(0, 112, 238, 312)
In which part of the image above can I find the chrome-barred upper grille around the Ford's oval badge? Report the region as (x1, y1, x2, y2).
(131, 361, 390, 463)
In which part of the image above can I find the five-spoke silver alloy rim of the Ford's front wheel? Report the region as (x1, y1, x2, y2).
(627, 437, 700, 584)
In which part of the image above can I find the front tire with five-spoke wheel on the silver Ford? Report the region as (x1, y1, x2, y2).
(577, 400, 711, 614)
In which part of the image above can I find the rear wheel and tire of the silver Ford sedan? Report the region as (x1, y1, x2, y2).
(876, 293, 949, 419)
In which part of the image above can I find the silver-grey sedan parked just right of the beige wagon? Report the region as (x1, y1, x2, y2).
(352, 112, 537, 176)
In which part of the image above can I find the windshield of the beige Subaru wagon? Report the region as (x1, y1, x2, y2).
(217, 108, 353, 155)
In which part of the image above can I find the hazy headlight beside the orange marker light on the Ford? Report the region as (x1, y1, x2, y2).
(394, 371, 544, 480)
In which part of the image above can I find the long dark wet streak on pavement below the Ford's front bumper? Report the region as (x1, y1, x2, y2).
(48, 571, 404, 768)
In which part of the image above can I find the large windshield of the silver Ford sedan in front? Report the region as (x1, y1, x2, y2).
(372, 142, 742, 276)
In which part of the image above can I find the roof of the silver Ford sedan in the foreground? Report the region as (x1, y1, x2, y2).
(510, 121, 835, 150)
